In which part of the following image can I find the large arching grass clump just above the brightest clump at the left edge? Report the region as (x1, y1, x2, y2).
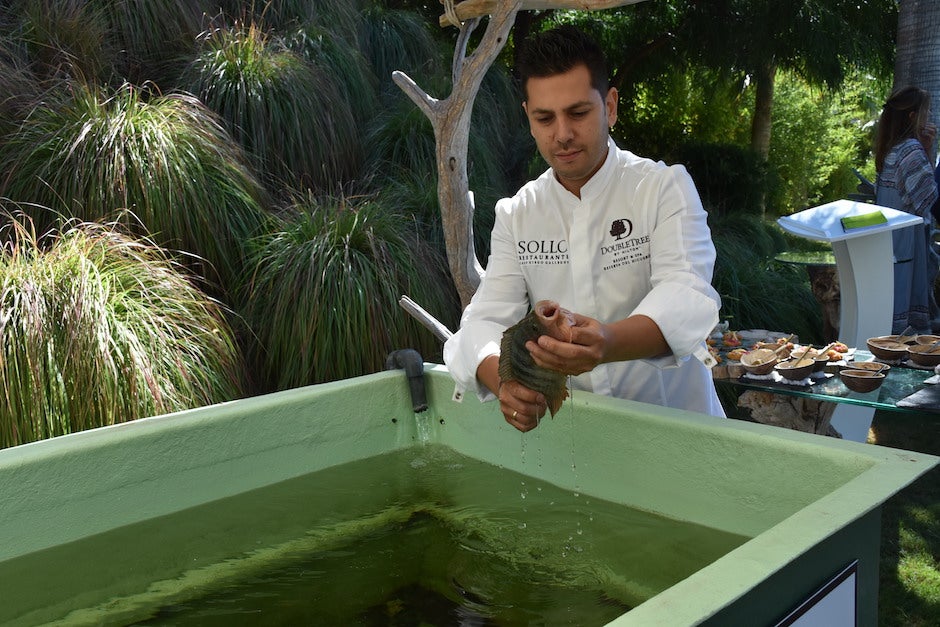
(0, 84, 266, 286)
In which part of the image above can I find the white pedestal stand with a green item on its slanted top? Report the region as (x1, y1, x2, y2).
(777, 200, 923, 442)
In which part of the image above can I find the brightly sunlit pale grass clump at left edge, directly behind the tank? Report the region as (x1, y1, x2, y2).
(0, 215, 242, 447)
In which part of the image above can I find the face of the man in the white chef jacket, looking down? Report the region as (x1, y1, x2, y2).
(522, 65, 617, 196)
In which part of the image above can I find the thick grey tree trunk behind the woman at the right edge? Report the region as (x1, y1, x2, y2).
(894, 0, 940, 162)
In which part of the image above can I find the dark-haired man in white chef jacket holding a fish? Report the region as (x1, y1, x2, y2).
(444, 26, 724, 432)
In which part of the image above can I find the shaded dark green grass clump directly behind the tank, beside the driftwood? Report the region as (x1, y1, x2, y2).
(244, 195, 459, 390)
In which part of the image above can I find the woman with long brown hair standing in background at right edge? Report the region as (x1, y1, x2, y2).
(875, 87, 940, 334)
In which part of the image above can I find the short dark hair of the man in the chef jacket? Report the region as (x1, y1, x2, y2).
(516, 25, 610, 97)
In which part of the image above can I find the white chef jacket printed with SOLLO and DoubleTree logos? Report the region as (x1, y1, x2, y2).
(444, 139, 725, 416)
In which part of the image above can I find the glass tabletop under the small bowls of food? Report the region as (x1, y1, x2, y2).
(715, 350, 940, 412)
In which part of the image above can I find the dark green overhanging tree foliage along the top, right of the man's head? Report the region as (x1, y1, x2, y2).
(554, 0, 897, 156)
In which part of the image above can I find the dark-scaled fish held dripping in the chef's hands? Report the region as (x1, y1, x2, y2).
(499, 300, 574, 417)
